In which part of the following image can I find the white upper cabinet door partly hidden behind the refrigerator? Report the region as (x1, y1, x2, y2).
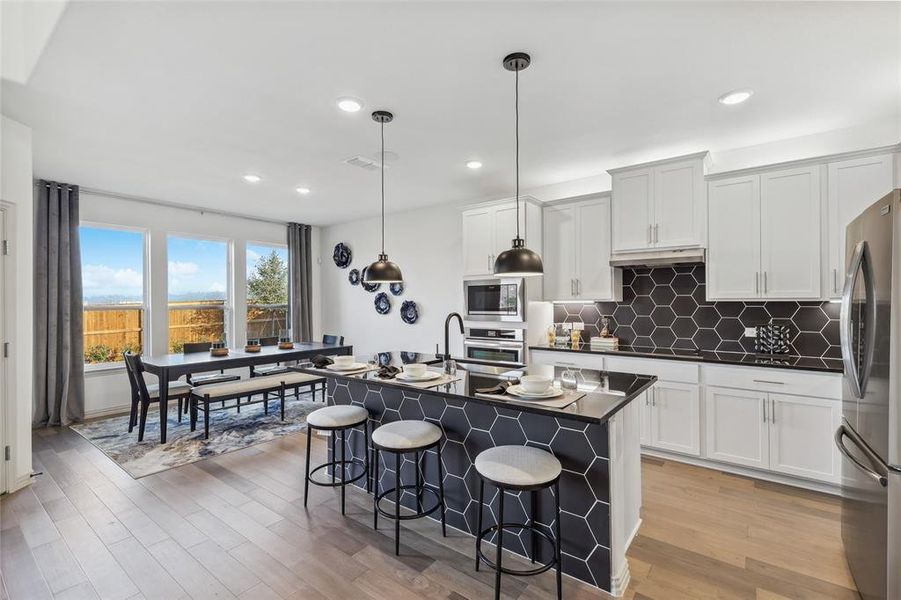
(826, 154, 893, 298)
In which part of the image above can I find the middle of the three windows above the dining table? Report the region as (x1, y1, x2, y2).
(168, 236, 229, 352)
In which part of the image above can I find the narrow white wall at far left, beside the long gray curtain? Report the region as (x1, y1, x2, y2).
(0, 115, 34, 491)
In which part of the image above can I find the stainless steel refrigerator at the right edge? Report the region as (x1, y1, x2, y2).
(835, 190, 901, 600)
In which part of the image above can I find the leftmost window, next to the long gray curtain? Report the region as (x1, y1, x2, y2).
(79, 225, 146, 364)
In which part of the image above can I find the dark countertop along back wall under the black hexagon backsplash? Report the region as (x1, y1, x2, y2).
(529, 344, 843, 373)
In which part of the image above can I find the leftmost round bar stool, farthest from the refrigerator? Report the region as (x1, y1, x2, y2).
(303, 404, 370, 515)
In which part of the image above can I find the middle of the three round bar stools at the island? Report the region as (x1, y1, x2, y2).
(372, 420, 447, 555)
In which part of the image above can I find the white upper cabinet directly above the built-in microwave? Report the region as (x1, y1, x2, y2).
(462, 198, 541, 277)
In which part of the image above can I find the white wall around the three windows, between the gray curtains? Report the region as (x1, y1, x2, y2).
(79, 192, 322, 418)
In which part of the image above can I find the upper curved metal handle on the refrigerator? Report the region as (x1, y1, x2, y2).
(839, 241, 876, 398)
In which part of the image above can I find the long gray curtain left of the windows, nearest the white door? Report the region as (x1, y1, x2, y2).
(33, 180, 84, 426)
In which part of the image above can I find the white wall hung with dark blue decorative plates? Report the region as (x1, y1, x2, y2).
(320, 205, 463, 355)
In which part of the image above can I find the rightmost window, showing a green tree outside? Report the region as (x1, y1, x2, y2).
(247, 244, 288, 339)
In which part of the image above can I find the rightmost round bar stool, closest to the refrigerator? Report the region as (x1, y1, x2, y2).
(475, 446, 563, 600)
